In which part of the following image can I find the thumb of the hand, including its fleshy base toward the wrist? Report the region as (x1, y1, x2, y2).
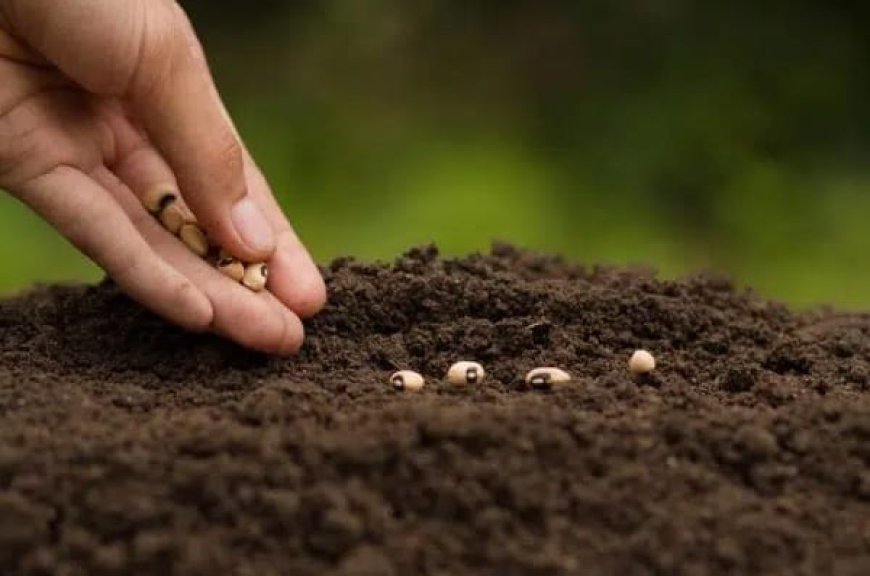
(5, 0, 275, 261)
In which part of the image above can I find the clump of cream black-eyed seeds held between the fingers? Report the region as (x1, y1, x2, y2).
(142, 186, 269, 292)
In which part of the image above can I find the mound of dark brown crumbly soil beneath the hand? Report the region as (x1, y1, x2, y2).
(0, 246, 870, 576)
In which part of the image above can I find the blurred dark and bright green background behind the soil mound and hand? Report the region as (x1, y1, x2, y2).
(0, 0, 870, 308)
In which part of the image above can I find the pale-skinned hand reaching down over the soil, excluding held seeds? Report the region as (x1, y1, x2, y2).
(0, 0, 326, 355)
